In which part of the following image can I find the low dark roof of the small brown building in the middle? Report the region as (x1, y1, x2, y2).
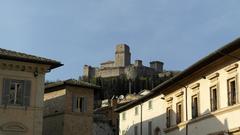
(45, 79, 101, 93)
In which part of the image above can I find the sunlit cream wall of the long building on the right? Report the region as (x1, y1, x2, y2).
(119, 61, 240, 135)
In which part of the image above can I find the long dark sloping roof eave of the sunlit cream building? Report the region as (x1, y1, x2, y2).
(115, 38, 240, 112)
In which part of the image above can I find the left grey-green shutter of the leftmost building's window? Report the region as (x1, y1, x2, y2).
(2, 79, 11, 107)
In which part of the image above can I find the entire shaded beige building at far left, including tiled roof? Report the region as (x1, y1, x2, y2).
(0, 49, 62, 135)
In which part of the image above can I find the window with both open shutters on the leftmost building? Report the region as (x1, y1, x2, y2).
(2, 79, 31, 106)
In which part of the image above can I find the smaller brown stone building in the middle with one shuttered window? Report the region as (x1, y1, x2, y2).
(43, 80, 100, 135)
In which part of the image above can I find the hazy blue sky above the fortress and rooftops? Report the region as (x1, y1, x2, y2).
(0, 0, 240, 81)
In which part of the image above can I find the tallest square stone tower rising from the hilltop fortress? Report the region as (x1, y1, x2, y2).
(115, 44, 131, 67)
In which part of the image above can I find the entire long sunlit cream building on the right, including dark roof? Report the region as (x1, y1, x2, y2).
(115, 39, 240, 135)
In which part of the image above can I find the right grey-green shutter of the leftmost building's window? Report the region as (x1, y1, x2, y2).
(23, 80, 31, 107)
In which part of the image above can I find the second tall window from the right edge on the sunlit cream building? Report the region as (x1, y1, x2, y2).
(210, 86, 218, 112)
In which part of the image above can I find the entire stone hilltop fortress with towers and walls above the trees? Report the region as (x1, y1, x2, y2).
(83, 44, 164, 79)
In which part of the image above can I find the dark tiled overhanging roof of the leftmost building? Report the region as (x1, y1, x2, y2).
(0, 48, 63, 69)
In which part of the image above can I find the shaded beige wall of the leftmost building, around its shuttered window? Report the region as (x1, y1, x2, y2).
(0, 60, 47, 135)
